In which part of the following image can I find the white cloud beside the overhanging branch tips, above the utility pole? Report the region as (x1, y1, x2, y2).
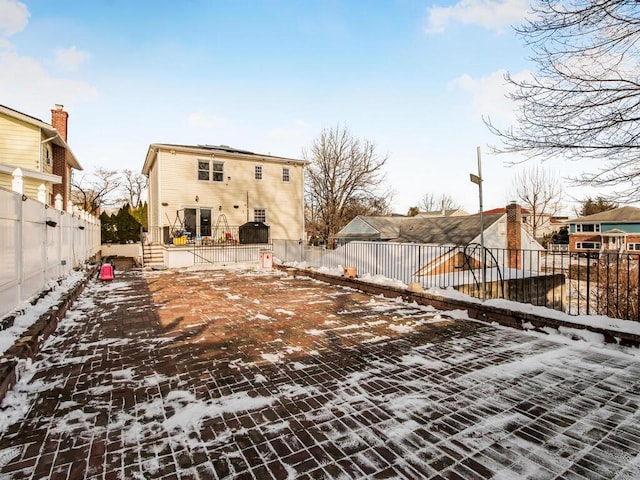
(448, 70, 531, 124)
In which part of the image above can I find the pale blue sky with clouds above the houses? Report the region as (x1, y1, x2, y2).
(0, 0, 608, 213)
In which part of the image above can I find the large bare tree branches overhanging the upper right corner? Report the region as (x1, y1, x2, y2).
(485, 0, 640, 202)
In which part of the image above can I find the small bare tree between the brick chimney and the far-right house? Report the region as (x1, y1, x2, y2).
(513, 166, 562, 238)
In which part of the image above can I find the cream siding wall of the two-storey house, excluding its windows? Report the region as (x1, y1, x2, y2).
(149, 149, 303, 240)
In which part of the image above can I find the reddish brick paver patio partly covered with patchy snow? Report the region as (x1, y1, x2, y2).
(0, 270, 640, 479)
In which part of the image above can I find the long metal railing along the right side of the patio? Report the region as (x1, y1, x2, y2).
(274, 241, 640, 320)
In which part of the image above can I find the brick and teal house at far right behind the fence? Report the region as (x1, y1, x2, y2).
(567, 207, 640, 253)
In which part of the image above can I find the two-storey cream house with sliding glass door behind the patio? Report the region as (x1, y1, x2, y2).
(142, 143, 307, 243)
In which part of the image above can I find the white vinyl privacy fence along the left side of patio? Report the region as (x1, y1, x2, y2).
(0, 188, 100, 318)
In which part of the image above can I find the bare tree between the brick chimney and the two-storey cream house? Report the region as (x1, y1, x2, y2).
(71, 168, 121, 215)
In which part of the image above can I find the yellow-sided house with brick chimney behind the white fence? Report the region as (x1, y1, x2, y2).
(0, 105, 82, 208)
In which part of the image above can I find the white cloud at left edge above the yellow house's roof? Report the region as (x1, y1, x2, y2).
(0, 43, 98, 114)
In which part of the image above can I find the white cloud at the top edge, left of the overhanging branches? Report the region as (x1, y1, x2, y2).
(426, 0, 529, 33)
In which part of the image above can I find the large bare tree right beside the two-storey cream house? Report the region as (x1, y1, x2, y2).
(303, 126, 390, 240)
